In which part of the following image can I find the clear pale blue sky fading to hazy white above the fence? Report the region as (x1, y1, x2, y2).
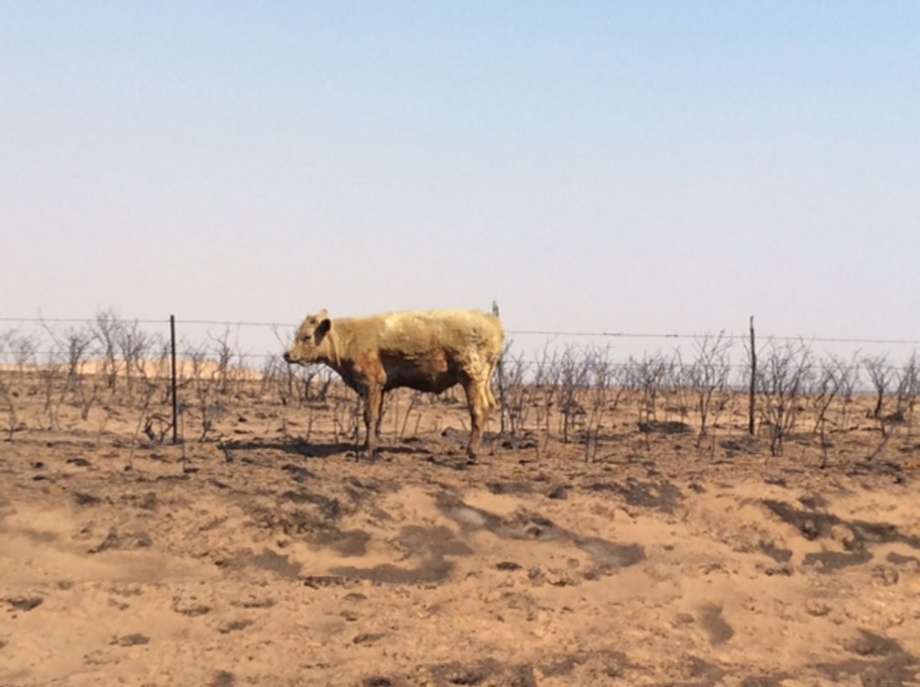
(0, 1, 920, 354)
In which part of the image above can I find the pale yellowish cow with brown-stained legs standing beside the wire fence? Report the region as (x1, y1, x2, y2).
(283, 309, 505, 463)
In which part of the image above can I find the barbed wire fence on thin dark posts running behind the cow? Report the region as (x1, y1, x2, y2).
(0, 305, 920, 452)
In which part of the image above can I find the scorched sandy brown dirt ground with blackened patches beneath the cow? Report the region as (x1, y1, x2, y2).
(0, 384, 920, 687)
